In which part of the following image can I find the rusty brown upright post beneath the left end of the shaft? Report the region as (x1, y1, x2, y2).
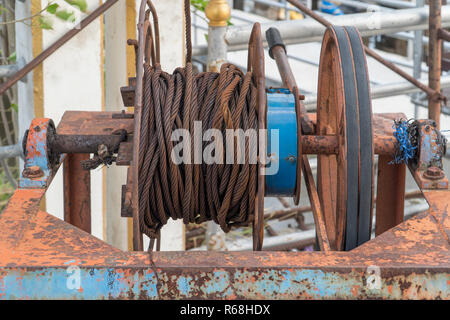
(64, 154, 91, 233)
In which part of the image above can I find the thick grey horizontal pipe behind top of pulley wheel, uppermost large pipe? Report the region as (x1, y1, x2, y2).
(193, 5, 450, 55)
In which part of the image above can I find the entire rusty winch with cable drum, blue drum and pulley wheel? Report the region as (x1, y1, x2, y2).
(0, 0, 450, 297)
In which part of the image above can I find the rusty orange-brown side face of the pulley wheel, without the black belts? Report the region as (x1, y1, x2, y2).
(317, 28, 354, 250)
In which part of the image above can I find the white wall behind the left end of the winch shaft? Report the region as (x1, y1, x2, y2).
(41, 0, 103, 238)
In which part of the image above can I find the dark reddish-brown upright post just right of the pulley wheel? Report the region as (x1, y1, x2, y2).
(375, 155, 406, 236)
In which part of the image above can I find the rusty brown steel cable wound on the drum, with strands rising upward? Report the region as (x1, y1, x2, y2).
(138, 0, 258, 238)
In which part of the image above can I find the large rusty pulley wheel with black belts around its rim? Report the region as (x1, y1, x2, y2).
(317, 26, 374, 250)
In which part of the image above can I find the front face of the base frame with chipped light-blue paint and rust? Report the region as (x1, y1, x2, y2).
(0, 267, 450, 299)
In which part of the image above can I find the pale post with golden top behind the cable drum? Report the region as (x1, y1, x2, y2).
(205, 0, 231, 251)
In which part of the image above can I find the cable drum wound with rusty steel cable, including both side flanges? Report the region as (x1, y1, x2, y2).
(132, 1, 266, 250)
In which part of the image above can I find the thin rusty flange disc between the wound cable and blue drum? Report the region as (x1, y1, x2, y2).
(247, 23, 267, 251)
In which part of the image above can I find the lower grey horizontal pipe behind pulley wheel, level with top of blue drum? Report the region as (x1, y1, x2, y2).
(304, 76, 450, 110)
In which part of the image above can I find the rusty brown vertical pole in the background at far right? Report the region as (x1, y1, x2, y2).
(428, 0, 442, 129)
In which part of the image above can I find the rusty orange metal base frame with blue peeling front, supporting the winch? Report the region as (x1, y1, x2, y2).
(0, 112, 450, 299)
